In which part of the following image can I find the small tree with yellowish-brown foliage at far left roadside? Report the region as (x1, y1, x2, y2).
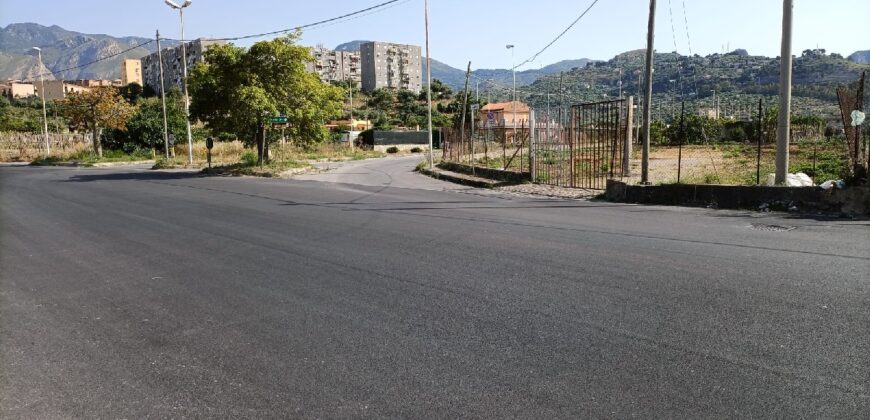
(60, 86, 135, 157)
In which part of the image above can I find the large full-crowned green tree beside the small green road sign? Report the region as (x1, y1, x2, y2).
(188, 32, 344, 161)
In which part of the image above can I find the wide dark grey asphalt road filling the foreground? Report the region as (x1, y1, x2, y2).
(0, 158, 870, 418)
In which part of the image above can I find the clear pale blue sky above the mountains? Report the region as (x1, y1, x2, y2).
(0, 0, 870, 70)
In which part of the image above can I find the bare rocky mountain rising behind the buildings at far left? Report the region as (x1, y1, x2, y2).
(0, 23, 177, 80)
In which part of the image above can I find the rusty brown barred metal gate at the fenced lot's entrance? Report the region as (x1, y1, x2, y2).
(532, 100, 631, 189)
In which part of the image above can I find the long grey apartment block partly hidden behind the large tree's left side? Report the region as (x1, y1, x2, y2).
(141, 38, 226, 93)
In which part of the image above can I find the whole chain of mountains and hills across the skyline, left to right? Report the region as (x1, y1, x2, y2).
(0, 23, 870, 106)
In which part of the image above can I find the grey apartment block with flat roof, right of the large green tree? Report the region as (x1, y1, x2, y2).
(360, 42, 423, 93)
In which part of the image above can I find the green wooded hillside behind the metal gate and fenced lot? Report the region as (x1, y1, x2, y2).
(520, 50, 870, 120)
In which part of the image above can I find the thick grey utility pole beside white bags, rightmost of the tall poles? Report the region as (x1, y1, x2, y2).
(774, 0, 794, 185)
